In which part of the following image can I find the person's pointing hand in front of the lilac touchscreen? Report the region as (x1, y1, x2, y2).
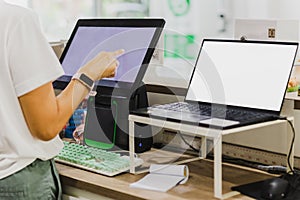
(79, 49, 124, 81)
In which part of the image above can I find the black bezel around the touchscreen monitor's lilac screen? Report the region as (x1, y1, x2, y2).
(53, 18, 165, 93)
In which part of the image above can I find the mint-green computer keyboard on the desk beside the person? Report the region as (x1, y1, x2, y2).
(55, 141, 143, 176)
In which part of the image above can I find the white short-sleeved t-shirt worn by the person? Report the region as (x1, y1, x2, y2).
(0, 0, 64, 179)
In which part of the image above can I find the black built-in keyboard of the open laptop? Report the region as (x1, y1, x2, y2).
(151, 102, 271, 121)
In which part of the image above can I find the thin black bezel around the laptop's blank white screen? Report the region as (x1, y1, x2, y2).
(184, 38, 299, 115)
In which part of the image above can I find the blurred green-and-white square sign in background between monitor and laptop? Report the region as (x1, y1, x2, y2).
(164, 34, 196, 59)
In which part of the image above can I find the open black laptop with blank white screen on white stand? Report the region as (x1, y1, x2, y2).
(132, 39, 298, 129)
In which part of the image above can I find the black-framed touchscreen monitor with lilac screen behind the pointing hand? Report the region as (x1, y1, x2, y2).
(54, 18, 165, 92)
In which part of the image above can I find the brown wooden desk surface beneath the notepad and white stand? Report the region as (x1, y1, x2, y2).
(56, 159, 271, 200)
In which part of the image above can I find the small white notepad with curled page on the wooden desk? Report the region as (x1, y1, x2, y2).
(130, 164, 189, 192)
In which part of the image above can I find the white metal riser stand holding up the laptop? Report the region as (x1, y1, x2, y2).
(128, 115, 294, 199)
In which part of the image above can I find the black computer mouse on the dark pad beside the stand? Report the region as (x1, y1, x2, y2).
(261, 178, 289, 200)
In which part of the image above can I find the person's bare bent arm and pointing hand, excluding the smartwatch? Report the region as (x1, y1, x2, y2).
(19, 50, 123, 141)
